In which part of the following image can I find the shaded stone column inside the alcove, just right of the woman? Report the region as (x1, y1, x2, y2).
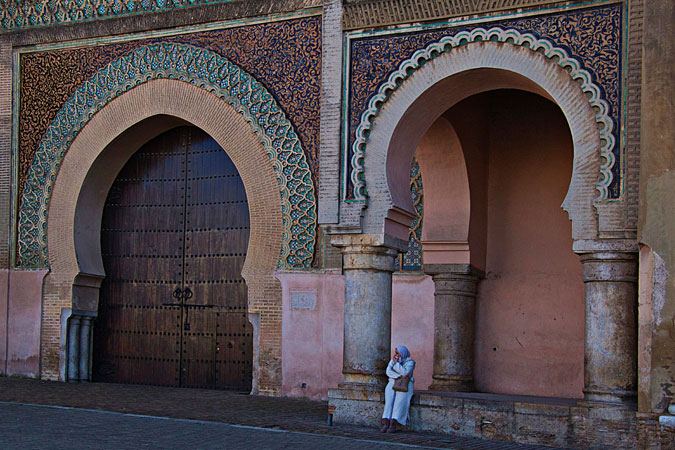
(424, 264, 480, 392)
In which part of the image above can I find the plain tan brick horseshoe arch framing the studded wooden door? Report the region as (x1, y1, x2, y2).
(43, 79, 283, 391)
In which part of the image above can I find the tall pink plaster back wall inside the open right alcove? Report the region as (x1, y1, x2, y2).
(452, 91, 584, 398)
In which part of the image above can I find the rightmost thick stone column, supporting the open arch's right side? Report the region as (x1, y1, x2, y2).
(581, 252, 637, 402)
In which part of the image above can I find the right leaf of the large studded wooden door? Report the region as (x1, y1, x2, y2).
(184, 129, 252, 390)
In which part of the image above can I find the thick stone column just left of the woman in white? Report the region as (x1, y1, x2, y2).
(332, 235, 398, 389)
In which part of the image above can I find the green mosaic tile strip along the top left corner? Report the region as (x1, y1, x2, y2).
(0, 0, 232, 29)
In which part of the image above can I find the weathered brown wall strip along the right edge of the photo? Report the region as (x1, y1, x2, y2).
(638, 0, 675, 420)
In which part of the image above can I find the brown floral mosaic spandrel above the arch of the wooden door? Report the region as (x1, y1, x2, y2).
(19, 16, 321, 200)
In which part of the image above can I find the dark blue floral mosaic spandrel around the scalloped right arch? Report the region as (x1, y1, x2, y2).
(345, 4, 622, 199)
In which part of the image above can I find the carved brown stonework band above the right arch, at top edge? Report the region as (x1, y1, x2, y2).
(342, 0, 556, 30)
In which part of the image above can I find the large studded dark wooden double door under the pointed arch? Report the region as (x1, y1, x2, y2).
(94, 127, 252, 391)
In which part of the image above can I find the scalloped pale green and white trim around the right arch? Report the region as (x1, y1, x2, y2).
(350, 27, 616, 200)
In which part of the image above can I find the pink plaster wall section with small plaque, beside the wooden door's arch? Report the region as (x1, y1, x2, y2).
(277, 272, 345, 399)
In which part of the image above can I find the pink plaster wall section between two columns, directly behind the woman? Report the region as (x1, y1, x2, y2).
(391, 273, 434, 390)
